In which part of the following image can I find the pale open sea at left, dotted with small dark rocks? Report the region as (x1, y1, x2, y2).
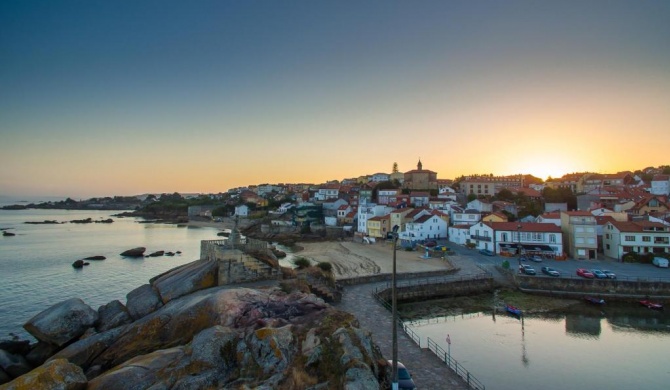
(0, 210, 221, 339)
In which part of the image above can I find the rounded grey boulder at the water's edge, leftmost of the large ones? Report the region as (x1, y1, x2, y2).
(23, 298, 98, 346)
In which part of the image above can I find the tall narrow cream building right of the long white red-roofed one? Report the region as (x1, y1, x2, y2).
(561, 211, 598, 260)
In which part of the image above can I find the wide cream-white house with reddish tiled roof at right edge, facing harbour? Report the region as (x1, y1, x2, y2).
(603, 221, 670, 260)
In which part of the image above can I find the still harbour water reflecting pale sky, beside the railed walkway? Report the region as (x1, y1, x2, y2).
(413, 304, 670, 390)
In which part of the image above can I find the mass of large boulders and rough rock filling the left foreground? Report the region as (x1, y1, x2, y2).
(0, 260, 389, 390)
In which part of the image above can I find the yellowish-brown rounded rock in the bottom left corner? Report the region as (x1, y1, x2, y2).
(2, 359, 88, 390)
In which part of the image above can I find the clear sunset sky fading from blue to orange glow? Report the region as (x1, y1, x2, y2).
(0, 0, 670, 197)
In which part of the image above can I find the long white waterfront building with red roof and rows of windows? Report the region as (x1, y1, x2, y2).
(469, 222, 563, 256)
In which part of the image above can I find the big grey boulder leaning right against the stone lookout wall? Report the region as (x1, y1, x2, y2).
(152, 260, 219, 303)
